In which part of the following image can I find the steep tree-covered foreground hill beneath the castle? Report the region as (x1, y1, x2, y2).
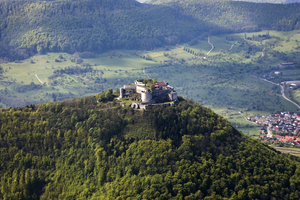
(0, 90, 300, 200)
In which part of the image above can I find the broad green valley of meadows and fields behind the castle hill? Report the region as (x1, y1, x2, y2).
(0, 31, 300, 135)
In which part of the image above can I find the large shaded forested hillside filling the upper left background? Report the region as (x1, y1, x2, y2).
(0, 0, 203, 59)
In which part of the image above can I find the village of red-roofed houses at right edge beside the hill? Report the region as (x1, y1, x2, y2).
(247, 111, 300, 145)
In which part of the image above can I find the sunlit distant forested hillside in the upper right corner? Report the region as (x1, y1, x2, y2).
(147, 0, 300, 34)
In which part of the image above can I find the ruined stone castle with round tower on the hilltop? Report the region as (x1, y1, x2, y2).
(119, 79, 178, 108)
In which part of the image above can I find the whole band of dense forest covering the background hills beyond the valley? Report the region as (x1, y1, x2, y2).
(0, 0, 300, 61)
